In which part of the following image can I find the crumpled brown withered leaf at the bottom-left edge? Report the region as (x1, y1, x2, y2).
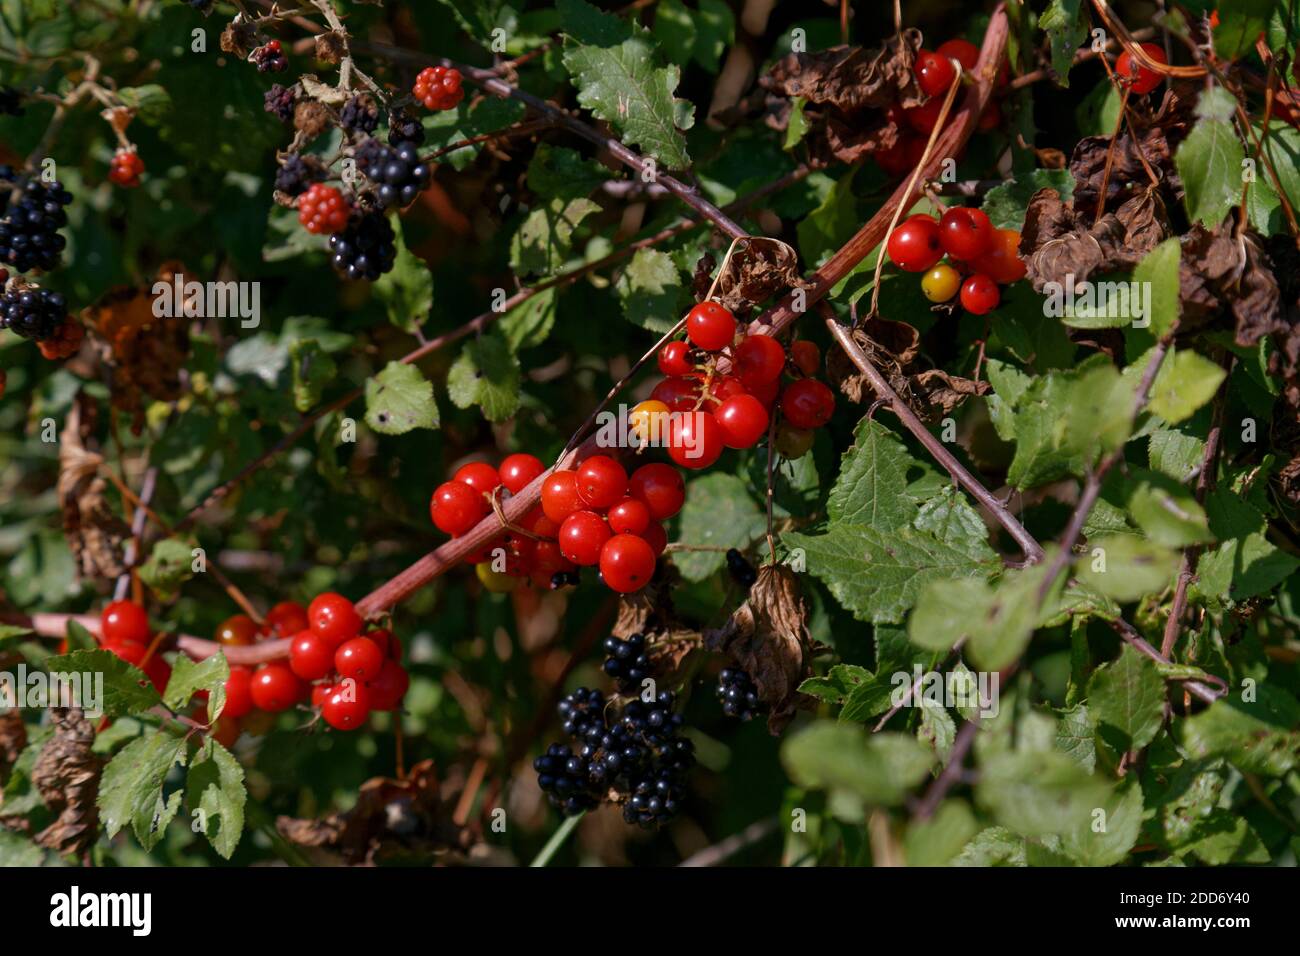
(31, 708, 104, 855)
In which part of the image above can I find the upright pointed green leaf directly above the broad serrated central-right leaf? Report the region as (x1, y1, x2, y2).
(826, 418, 917, 531)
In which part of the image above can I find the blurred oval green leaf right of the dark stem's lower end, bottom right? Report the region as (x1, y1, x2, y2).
(975, 750, 1110, 836)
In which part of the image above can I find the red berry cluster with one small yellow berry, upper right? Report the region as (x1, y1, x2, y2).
(885, 207, 1026, 315)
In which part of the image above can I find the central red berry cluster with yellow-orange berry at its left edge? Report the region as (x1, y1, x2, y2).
(644, 302, 835, 470)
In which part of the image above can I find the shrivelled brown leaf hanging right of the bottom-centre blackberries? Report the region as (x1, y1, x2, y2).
(705, 564, 814, 734)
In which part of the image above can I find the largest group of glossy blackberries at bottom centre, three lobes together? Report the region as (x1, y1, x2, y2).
(533, 688, 696, 829)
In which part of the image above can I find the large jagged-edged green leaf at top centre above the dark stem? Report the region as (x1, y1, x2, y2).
(562, 0, 694, 169)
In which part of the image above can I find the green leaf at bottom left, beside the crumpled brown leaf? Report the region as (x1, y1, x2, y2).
(98, 730, 186, 849)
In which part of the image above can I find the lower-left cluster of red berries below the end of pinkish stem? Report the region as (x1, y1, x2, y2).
(217, 592, 411, 730)
